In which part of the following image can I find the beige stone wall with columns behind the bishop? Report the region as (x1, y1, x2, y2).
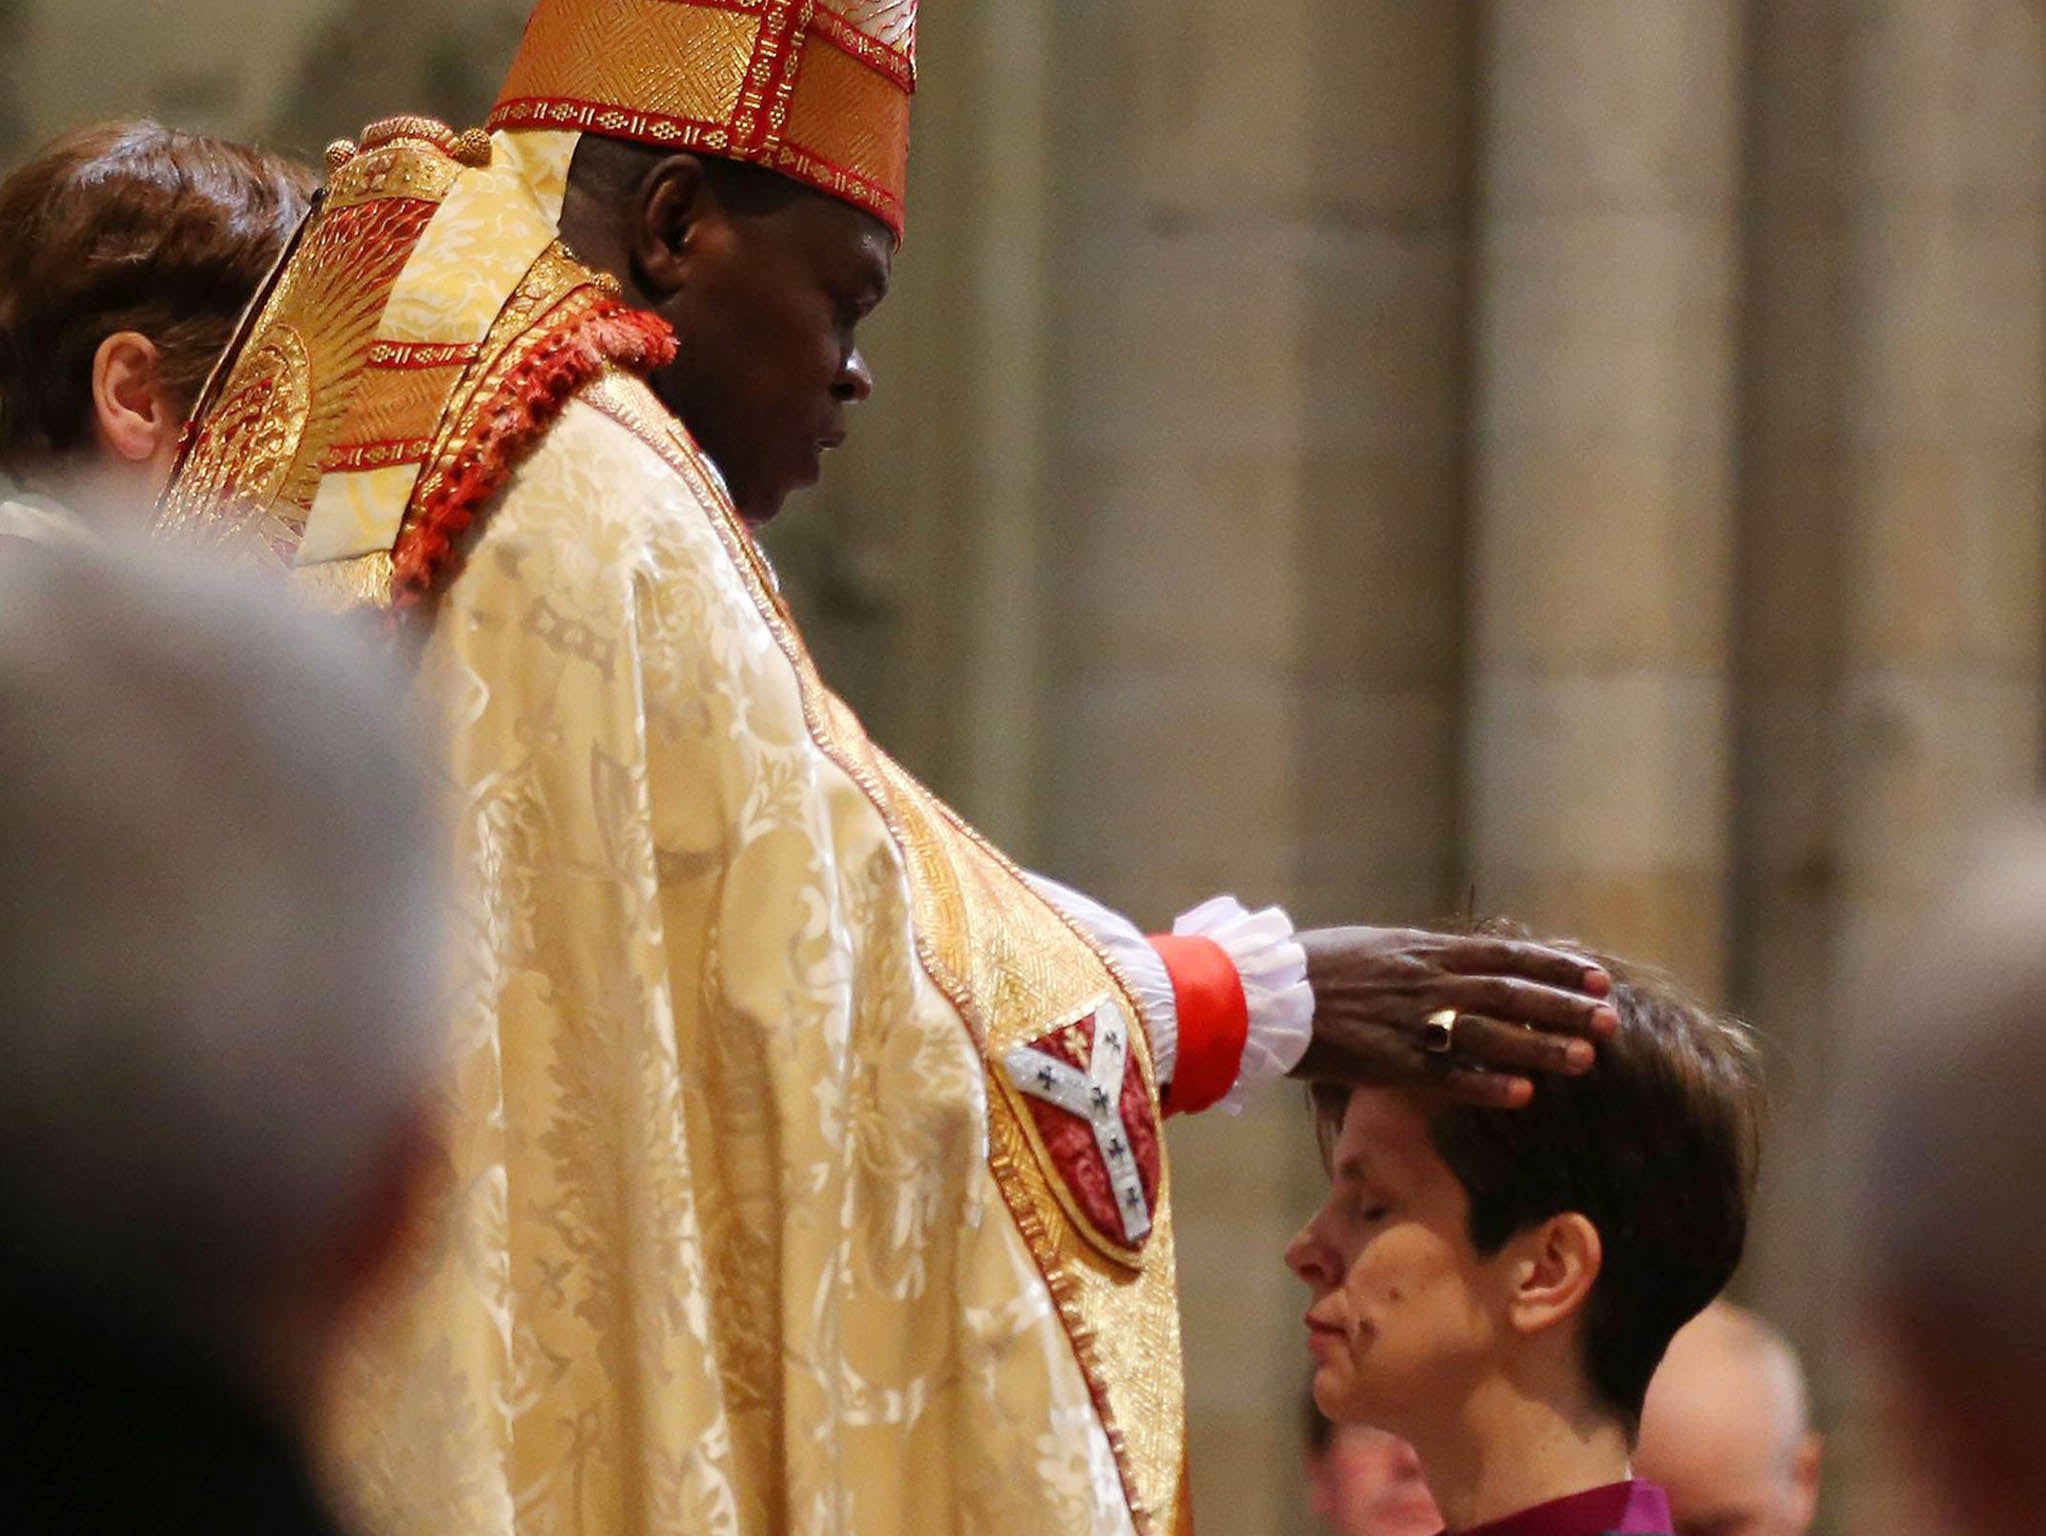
(0, 0, 2046, 1536)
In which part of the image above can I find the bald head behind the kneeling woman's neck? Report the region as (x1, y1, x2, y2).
(1635, 1301, 1821, 1536)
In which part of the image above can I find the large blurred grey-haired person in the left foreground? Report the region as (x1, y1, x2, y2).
(0, 540, 446, 1536)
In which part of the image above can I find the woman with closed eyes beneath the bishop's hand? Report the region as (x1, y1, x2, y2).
(1287, 959, 1762, 1536)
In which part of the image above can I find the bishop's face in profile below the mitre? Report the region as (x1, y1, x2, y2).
(655, 179, 894, 526)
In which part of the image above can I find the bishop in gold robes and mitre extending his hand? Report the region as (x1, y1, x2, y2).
(160, 0, 1614, 1536)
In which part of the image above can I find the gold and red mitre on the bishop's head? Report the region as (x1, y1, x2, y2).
(491, 0, 917, 237)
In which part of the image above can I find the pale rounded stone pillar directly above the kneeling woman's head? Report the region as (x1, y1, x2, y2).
(1469, 0, 1747, 994)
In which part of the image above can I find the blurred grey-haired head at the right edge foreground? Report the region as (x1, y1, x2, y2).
(1841, 820, 2046, 1536)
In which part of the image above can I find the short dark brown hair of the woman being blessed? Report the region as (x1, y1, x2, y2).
(1314, 943, 1764, 1434)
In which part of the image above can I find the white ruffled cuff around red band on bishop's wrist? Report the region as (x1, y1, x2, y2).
(1029, 875, 1314, 1115)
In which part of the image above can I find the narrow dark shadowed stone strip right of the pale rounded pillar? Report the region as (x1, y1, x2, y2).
(1729, 0, 1858, 1417)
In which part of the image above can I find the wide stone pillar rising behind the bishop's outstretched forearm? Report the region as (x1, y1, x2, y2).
(1046, 0, 1477, 1532)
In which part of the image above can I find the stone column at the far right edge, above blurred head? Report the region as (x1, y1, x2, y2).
(1816, 0, 2046, 1532)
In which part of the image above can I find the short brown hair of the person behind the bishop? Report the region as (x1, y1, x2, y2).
(0, 121, 315, 468)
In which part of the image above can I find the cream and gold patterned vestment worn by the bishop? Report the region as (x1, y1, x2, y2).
(160, 0, 1191, 1536)
